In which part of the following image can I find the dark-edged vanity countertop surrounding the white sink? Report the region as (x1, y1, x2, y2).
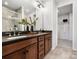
(2, 33, 48, 46)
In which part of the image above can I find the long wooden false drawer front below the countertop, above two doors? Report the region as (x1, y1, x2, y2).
(2, 38, 37, 56)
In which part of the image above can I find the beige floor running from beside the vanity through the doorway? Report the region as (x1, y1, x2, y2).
(44, 40, 77, 59)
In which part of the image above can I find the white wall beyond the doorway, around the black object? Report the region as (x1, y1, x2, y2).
(58, 13, 73, 40)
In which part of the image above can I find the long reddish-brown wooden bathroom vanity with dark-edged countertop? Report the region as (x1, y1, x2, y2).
(2, 32, 52, 59)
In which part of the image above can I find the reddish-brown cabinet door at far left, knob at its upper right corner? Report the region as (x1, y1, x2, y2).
(3, 49, 25, 59)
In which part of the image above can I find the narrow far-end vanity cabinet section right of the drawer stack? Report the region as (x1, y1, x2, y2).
(45, 33, 52, 54)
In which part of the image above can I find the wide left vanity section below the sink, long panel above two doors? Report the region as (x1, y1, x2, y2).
(3, 38, 37, 59)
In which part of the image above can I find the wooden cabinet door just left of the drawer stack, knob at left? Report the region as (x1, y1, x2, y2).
(26, 43, 37, 59)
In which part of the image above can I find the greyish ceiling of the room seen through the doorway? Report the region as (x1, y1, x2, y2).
(58, 4, 72, 15)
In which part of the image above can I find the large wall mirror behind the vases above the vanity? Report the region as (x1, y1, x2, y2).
(2, 0, 47, 32)
